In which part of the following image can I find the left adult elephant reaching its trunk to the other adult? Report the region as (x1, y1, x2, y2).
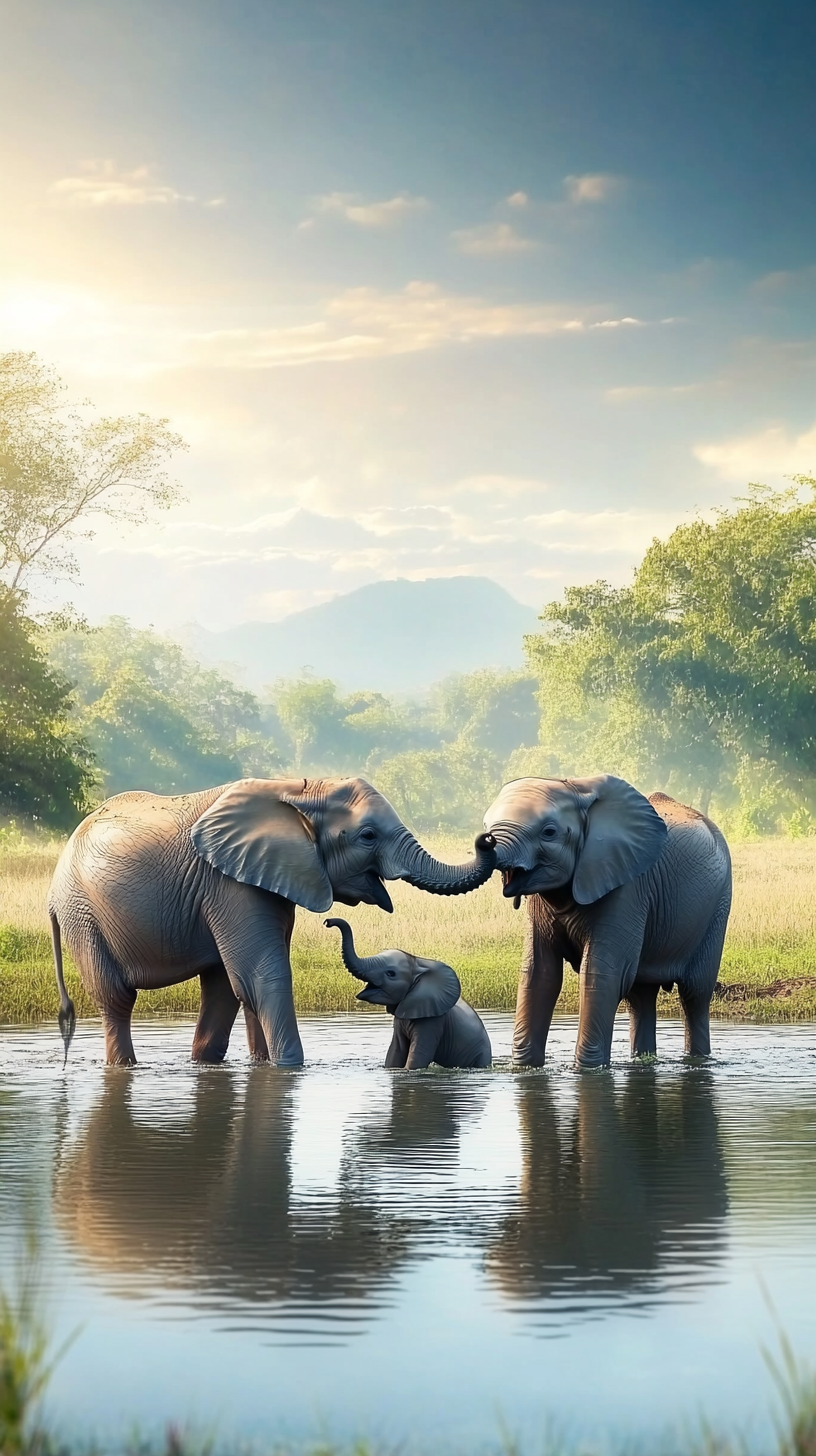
(48, 779, 495, 1067)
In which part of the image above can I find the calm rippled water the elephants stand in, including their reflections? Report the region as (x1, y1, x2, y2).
(0, 1016, 816, 1450)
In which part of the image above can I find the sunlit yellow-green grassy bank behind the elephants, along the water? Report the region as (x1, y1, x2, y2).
(0, 839, 816, 1022)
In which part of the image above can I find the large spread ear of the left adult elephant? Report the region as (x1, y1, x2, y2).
(189, 779, 334, 910)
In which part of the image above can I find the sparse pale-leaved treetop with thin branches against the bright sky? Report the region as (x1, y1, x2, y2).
(0, 352, 184, 591)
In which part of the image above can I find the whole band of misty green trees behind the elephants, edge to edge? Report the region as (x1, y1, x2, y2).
(0, 354, 816, 834)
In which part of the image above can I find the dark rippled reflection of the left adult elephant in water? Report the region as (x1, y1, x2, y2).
(55, 1069, 408, 1303)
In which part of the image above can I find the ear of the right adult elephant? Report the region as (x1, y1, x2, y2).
(568, 773, 666, 906)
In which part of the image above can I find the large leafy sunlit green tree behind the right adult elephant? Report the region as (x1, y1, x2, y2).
(526, 476, 816, 828)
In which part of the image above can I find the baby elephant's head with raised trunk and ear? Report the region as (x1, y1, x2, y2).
(323, 919, 462, 1021)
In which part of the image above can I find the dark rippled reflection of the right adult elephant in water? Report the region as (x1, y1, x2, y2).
(487, 1072, 729, 1302)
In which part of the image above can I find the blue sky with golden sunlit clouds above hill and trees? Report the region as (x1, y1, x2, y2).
(0, 0, 816, 629)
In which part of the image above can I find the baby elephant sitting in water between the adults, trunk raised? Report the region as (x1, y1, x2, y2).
(323, 920, 493, 1069)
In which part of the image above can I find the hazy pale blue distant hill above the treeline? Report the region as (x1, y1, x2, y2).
(175, 577, 536, 693)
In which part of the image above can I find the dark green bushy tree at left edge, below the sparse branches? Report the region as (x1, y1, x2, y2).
(0, 588, 95, 828)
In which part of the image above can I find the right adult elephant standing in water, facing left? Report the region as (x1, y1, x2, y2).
(485, 775, 731, 1067)
